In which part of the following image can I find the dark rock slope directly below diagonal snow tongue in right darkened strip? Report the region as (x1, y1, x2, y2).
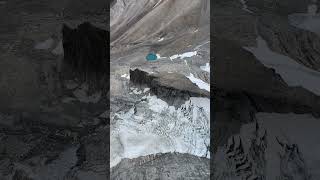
(213, 38, 320, 114)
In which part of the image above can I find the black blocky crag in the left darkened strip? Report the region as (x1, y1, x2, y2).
(62, 22, 109, 78)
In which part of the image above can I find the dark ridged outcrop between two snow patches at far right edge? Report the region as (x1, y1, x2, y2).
(257, 15, 320, 71)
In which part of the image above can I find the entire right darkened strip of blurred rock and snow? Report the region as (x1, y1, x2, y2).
(211, 0, 320, 179)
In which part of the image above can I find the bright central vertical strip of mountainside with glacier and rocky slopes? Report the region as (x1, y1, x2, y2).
(110, 0, 210, 179)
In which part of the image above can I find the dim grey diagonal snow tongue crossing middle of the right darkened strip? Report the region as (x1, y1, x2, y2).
(245, 37, 320, 95)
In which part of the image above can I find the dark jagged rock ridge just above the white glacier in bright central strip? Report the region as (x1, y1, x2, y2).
(130, 69, 210, 106)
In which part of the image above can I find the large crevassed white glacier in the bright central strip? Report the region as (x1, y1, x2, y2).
(110, 96, 210, 167)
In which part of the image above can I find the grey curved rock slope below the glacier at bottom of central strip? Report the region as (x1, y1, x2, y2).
(111, 153, 210, 180)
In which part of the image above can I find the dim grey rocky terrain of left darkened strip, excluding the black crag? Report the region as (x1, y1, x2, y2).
(0, 0, 109, 180)
